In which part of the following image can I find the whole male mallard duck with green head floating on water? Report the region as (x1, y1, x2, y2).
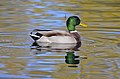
(30, 16, 86, 43)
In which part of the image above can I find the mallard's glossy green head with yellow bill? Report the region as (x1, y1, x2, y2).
(66, 16, 86, 31)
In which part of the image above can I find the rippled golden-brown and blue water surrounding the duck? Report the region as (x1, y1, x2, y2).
(0, 0, 120, 79)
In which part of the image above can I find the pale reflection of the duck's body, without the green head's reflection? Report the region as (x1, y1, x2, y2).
(31, 42, 81, 51)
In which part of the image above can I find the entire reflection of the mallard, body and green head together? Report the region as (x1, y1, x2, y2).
(31, 42, 84, 67)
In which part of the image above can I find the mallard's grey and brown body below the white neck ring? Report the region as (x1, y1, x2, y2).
(30, 29, 81, 43)
